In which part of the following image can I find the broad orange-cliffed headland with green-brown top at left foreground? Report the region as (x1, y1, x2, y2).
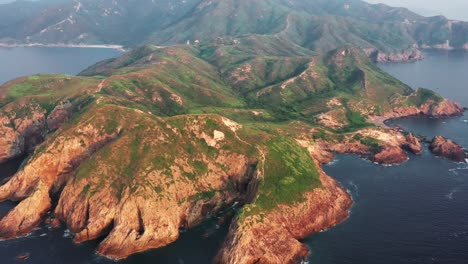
(0, 104, 257, 259)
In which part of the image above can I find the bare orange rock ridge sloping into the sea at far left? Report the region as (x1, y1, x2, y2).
(0, 116, 118, 239)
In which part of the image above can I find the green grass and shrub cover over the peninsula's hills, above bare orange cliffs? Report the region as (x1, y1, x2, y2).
(0, 41, 446, 221)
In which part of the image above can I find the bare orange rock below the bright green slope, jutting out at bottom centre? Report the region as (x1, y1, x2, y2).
(215, 162, 352, 263)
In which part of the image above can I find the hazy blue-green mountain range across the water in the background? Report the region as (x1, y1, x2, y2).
(0, 0, 468, 60)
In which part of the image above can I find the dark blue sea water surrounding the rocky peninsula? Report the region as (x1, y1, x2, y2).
(0, 49, 468, 264)
